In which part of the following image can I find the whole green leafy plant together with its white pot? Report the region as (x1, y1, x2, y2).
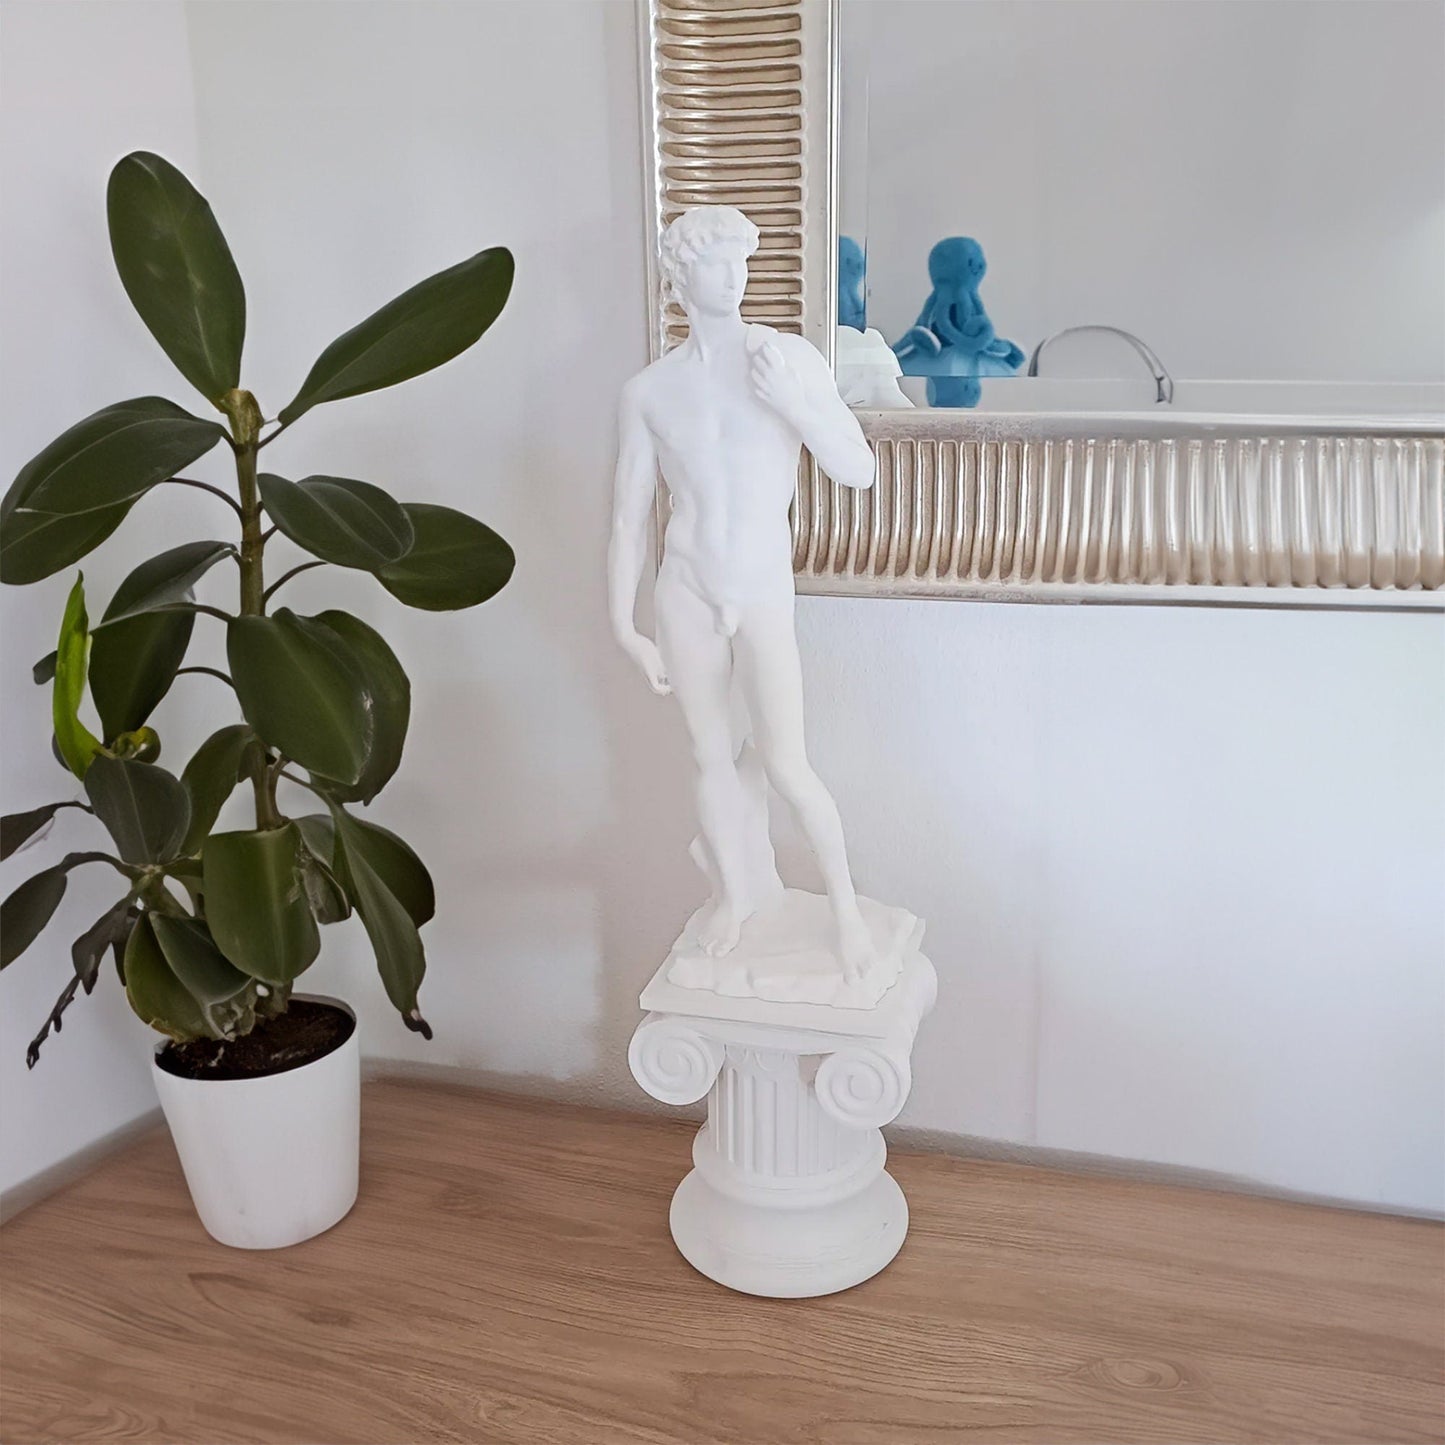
(0, 152, 513, 1248)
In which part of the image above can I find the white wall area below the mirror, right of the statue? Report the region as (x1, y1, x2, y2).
(799, 598, 1445, 1211)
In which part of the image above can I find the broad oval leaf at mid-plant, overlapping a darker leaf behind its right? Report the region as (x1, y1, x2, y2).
(225, 607, 376, 783)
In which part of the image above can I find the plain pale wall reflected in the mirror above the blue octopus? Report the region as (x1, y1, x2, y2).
(842, 0, 1445, 390)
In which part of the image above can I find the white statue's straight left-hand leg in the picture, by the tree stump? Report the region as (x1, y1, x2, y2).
(655, 579, 749, 954)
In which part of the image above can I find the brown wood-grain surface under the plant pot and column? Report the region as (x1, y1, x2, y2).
(0, 1082, 1445, 1445)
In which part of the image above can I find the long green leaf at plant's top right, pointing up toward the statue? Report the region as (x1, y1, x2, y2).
(280, 246, 514, 426)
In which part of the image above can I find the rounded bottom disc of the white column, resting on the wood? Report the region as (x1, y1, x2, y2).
(669, 1169, 907, 1299)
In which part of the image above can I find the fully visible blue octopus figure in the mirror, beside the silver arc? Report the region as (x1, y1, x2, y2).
(893, 236, 1023, 406)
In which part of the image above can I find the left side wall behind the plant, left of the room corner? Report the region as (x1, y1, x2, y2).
(0, 0, 225, 1189)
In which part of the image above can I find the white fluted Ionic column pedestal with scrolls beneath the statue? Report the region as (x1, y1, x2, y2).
(627, 951, 938, 1299)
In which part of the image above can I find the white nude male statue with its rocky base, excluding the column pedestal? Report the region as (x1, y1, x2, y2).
(608, 207, 916, 1007)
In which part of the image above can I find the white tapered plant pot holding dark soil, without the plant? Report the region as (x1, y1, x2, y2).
(150, 994, 361, 1250)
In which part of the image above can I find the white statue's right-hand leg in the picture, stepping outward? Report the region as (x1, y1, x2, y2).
(733, 591, 873, 977)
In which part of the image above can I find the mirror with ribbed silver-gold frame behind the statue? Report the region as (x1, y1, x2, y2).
(643, 0, 1445, 608)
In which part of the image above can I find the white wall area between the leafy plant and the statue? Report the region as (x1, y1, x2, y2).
(174, 0, 692, 1104)
